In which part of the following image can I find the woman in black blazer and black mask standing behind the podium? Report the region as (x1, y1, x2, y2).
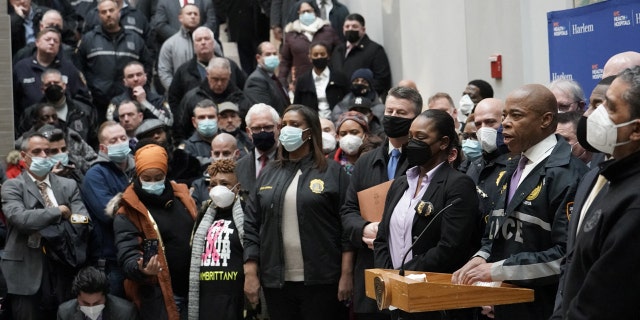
(374, 110, 478, 319)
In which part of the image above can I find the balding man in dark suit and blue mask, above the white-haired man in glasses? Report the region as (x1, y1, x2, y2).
(244, 42, 291, 115)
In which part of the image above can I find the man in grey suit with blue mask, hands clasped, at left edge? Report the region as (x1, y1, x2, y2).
(0, 133, 89, 320)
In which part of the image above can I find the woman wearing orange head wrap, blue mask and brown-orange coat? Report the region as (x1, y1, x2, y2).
(113, 144, 197, 320)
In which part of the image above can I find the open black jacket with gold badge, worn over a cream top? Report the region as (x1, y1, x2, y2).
(244, 156, 349, 288)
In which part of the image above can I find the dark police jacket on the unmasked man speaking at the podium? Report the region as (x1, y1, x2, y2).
(476, 135, 587, 319)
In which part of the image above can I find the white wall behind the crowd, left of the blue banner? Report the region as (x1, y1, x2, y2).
(343, 0, 573, 101)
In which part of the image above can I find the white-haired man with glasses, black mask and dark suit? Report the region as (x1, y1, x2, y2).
(236, 103, 280, 193)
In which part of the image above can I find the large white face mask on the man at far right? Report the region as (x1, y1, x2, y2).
(587, 105, 636, 155)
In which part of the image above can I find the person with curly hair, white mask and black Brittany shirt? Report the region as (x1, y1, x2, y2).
(189, 159, 244, 320)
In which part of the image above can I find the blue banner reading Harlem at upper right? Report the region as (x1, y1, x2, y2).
(547, 0, 640, 94)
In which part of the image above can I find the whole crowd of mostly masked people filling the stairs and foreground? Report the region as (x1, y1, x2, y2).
(0, 0, 640, 320)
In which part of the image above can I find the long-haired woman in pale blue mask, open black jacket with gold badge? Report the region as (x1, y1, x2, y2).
(244, 105, 353, 320)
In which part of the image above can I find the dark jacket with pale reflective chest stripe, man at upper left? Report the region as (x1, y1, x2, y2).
(77, 26, 152, 105)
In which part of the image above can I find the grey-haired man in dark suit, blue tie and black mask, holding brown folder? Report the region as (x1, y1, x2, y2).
(340, 87, 422, 319)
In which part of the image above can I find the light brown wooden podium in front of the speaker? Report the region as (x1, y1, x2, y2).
(365, 269, 533, 312)
